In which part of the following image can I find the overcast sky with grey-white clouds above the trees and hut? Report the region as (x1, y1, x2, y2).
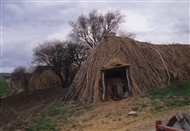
(0, 0, 190, 72)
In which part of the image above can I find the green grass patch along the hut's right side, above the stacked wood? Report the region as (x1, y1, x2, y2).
(147, 80, 190, 111)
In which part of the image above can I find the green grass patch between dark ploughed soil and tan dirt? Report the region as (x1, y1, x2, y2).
(27, 100, 93, 131)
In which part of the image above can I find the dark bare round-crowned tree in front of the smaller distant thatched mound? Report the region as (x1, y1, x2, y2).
(33, 40, 71, 88)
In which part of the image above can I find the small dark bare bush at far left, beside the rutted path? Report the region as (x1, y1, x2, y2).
(11, 66, 31, 91)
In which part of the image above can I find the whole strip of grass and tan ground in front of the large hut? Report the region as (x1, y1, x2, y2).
(27, 80, 190, 131)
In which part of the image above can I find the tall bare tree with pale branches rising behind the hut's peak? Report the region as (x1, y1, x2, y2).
(69, 9, 125, 49)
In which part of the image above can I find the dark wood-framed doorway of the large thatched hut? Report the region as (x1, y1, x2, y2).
(101, 65, 131, 101)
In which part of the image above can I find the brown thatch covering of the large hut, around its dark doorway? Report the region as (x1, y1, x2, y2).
(64, 37, 190, 103)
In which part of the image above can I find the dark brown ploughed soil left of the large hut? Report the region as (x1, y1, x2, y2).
(0, 88, 66, 131)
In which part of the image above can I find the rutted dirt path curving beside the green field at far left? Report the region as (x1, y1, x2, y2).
(1, 79, 19, 99)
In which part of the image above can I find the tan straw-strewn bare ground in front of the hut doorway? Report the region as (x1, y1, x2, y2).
(62, 96, 190, 131)
